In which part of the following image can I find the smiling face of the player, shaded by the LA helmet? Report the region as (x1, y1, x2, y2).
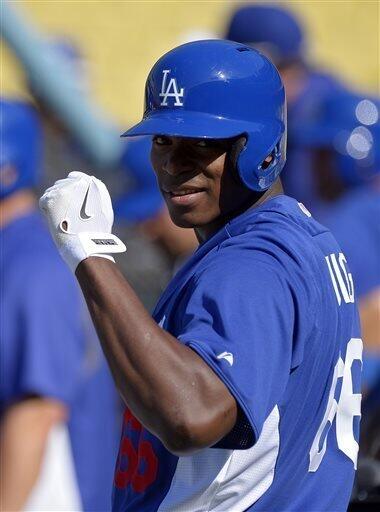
(151, 136, 255, 237)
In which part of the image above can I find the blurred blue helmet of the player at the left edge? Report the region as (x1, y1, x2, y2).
(0, 98, 42, 199)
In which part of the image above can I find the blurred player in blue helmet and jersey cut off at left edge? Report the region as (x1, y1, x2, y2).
(0, 98, 118, 512)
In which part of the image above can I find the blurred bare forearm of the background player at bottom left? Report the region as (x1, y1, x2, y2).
(0, 397, 65, 512)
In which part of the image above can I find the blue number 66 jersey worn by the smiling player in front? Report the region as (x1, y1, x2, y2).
(113, 196, 362, 512)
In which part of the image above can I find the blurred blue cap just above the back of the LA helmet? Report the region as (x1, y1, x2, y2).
(225, 5, 304, 64)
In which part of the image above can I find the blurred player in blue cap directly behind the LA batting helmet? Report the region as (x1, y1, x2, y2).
(225, 4, 343, 219)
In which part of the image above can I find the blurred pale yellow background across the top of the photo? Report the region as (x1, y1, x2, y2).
(1, 0, 380, 126)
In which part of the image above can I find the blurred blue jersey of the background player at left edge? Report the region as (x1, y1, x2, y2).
(0, 212, 118, 512)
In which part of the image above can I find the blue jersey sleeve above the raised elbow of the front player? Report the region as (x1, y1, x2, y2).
(178, 251, 299, 448)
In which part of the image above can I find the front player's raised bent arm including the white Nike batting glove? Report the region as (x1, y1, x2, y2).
(40, 172, 236, 453)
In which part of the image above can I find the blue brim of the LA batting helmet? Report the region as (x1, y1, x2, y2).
(121, 110, 268, 139)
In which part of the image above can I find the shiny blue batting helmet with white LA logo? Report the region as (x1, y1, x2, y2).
(123, 40, 286, 192)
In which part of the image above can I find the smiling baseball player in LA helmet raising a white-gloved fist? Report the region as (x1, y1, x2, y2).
(40, 40, 362, 512)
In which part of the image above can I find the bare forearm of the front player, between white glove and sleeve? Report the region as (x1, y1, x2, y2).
(76, 257, 236, 452)
